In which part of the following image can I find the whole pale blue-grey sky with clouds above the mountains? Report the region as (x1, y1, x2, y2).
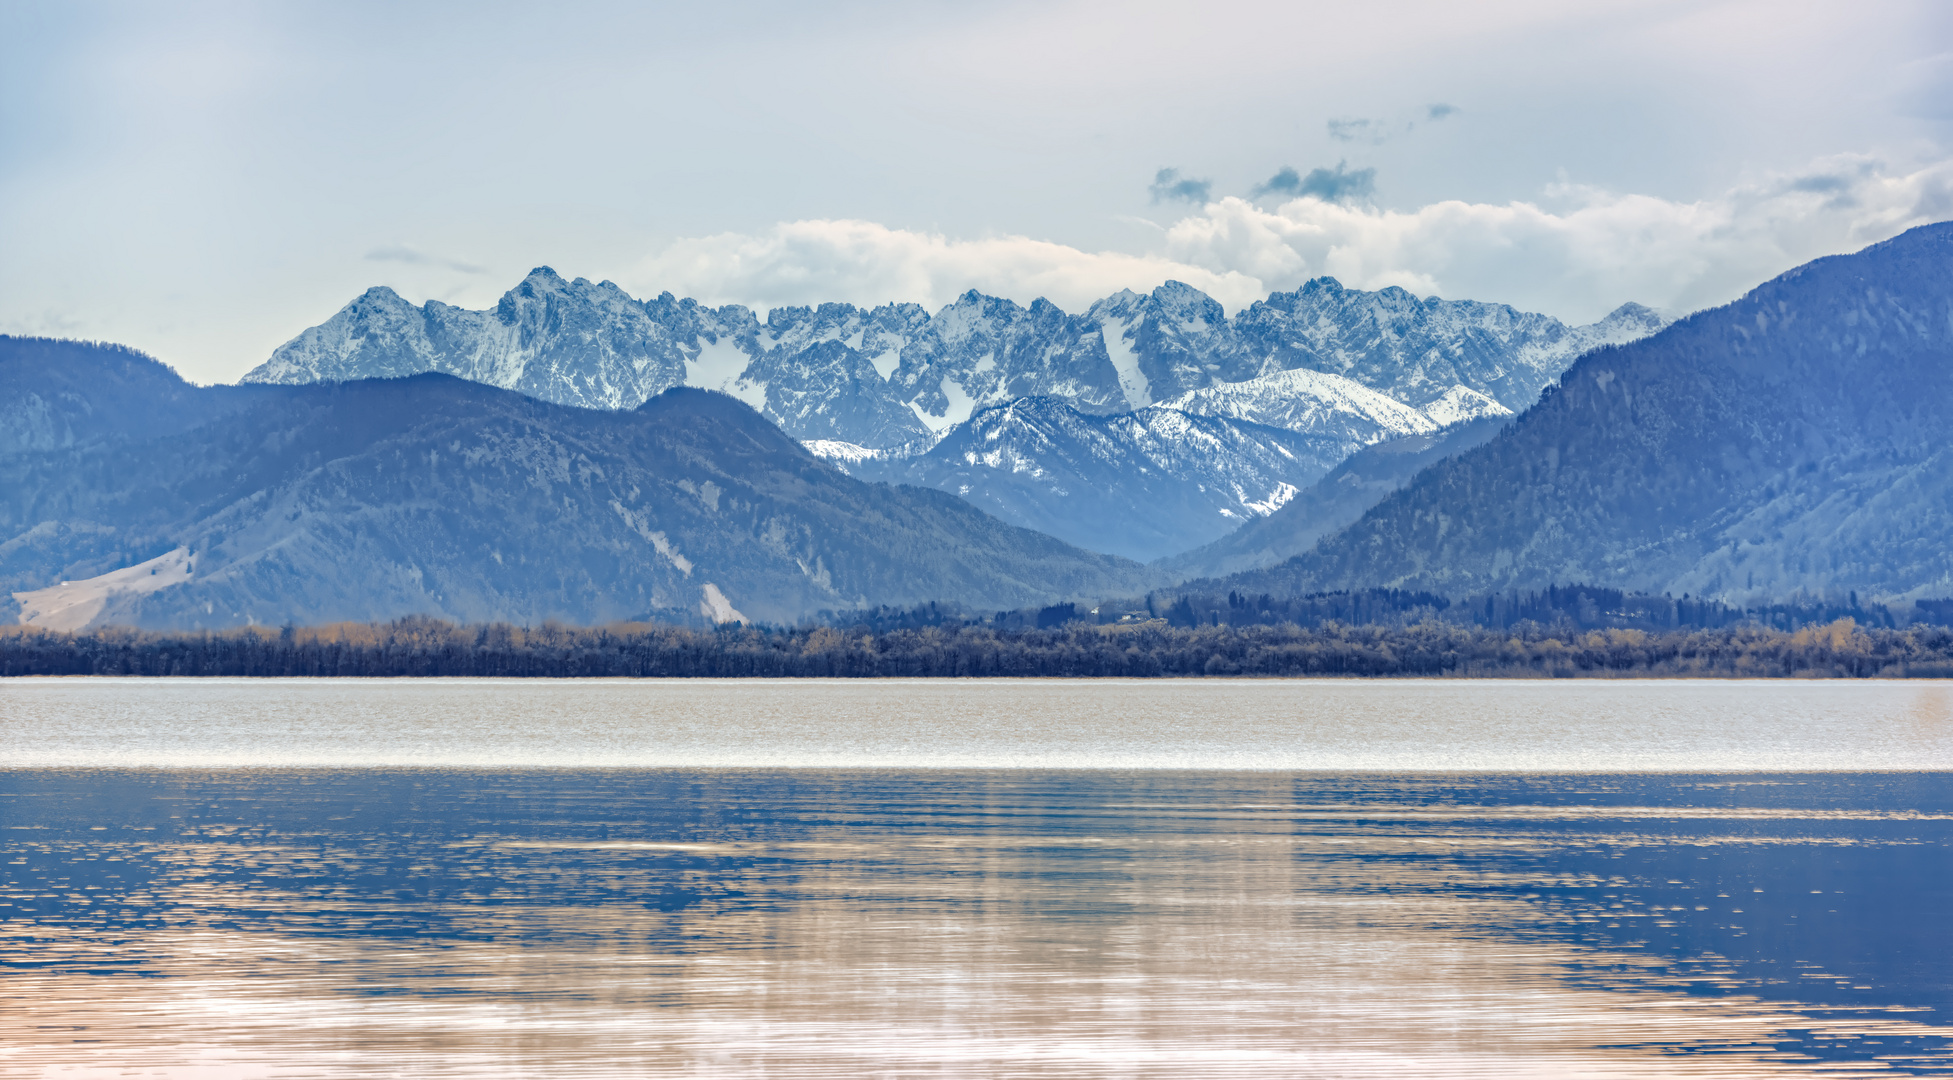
(0, 0, 1953, 383)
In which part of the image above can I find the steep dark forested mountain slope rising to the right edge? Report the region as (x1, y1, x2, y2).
(1236, 225, 1953, 602)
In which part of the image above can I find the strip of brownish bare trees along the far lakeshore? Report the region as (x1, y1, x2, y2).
(0, 617, 1953, 678)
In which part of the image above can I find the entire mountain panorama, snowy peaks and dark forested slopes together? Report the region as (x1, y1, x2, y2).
(0, 225, 1953, 627)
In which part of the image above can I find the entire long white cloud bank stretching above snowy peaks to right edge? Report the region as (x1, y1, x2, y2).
(623, 154, 1953, 322)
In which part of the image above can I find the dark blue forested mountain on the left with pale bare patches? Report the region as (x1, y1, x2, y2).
(0, 338, 1150, 627)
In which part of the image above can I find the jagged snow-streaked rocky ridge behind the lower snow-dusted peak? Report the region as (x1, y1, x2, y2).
(246, 268, 1662, 449)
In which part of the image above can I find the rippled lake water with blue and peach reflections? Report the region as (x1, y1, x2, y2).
(0, 680, 1953, 1078)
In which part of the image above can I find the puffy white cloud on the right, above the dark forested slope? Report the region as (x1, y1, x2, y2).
(1162, 156, 1953, 320)
